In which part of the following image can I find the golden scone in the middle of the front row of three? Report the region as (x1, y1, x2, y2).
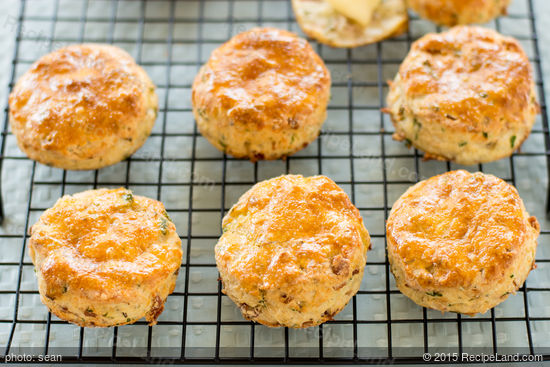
(216, 175, 370, 328)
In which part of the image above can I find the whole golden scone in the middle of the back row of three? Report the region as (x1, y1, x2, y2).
(192, 28, 330, 161)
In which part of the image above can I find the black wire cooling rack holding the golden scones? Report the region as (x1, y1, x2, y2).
(0, 0, 550, 364)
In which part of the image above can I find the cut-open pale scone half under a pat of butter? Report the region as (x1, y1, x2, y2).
(292, 0, 409, 48)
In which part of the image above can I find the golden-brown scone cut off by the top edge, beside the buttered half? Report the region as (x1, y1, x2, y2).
(407, 0, 510, 27)
